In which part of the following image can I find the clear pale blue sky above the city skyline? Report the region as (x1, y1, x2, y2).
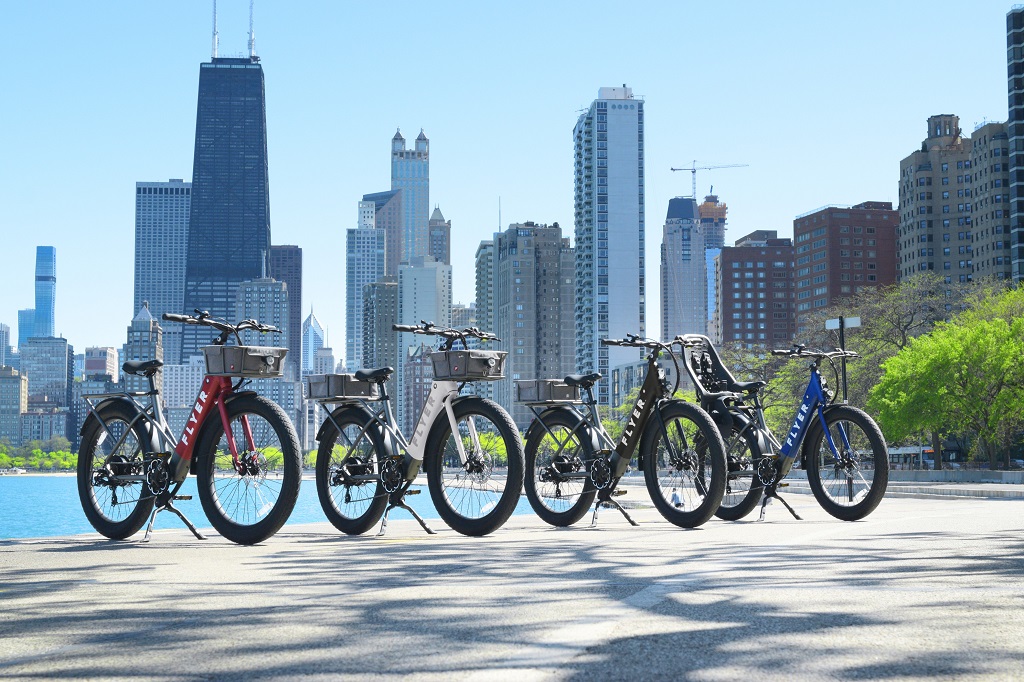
(0, 0, 1011, 357)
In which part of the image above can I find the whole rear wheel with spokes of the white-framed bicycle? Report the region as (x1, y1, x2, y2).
(316, 407, 387, 536)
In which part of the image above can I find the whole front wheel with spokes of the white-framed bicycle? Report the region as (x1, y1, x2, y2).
(423, 397, 524, 536)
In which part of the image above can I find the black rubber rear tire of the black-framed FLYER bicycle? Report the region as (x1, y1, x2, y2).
(523, 409, 597, 526)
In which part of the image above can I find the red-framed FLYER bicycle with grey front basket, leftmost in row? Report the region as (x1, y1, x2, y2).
(78, 310, 302, 545)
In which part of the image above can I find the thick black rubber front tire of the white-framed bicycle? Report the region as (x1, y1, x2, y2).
(423, 396, 525, 537)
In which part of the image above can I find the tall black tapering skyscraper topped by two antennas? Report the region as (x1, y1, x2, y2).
(181, 56, 270, 361)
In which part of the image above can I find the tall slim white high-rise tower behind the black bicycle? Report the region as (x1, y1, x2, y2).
(572, 84, 646, 404)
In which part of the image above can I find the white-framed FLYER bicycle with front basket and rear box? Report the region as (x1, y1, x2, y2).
(308, 322, 524, 536)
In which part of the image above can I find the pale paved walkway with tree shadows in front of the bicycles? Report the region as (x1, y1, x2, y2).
(0, 495, 1024, 682)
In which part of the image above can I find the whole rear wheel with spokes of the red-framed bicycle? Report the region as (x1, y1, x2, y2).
(77, 400, 154, 540)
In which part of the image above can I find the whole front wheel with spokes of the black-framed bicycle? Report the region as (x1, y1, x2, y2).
(640, 400, 726, 528)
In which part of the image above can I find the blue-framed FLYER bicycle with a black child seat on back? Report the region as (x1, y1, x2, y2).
(679, 334, 889, 521)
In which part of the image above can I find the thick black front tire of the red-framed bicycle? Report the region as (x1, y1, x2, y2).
(196, 394, 302, 545)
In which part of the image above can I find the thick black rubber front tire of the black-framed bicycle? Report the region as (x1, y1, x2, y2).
(640, 400, 727, 528)
